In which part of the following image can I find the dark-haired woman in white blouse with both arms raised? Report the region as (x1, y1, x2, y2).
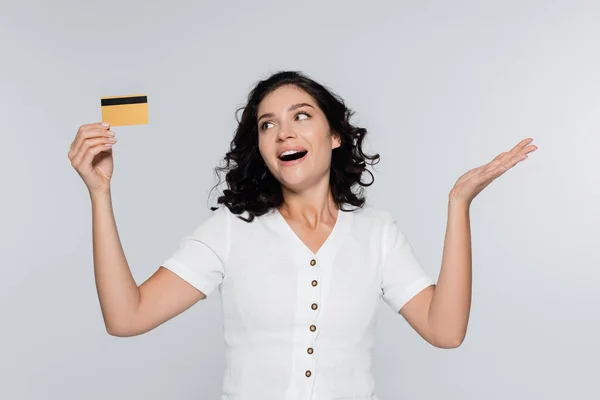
(69, 72, 535, 400)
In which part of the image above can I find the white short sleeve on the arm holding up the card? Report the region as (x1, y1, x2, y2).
(162, 206, 230, 297)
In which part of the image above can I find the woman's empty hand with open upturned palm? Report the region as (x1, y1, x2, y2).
(450, 138, 537, 206)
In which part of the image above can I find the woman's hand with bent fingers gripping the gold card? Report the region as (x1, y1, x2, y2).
(68, 123, 117, 194)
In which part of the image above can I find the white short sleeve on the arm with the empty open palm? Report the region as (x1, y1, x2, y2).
(381, 218, 435, 312)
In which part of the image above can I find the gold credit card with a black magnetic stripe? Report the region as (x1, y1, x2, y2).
(100, 94, 148, 126)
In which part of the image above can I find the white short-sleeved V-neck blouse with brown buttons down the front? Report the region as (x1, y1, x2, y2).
(163, 206, 435, 400)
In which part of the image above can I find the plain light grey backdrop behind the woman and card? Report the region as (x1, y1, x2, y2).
(0, 0, 600, 400)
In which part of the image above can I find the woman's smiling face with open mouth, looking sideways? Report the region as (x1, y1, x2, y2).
(257, 85, 340, 191)
